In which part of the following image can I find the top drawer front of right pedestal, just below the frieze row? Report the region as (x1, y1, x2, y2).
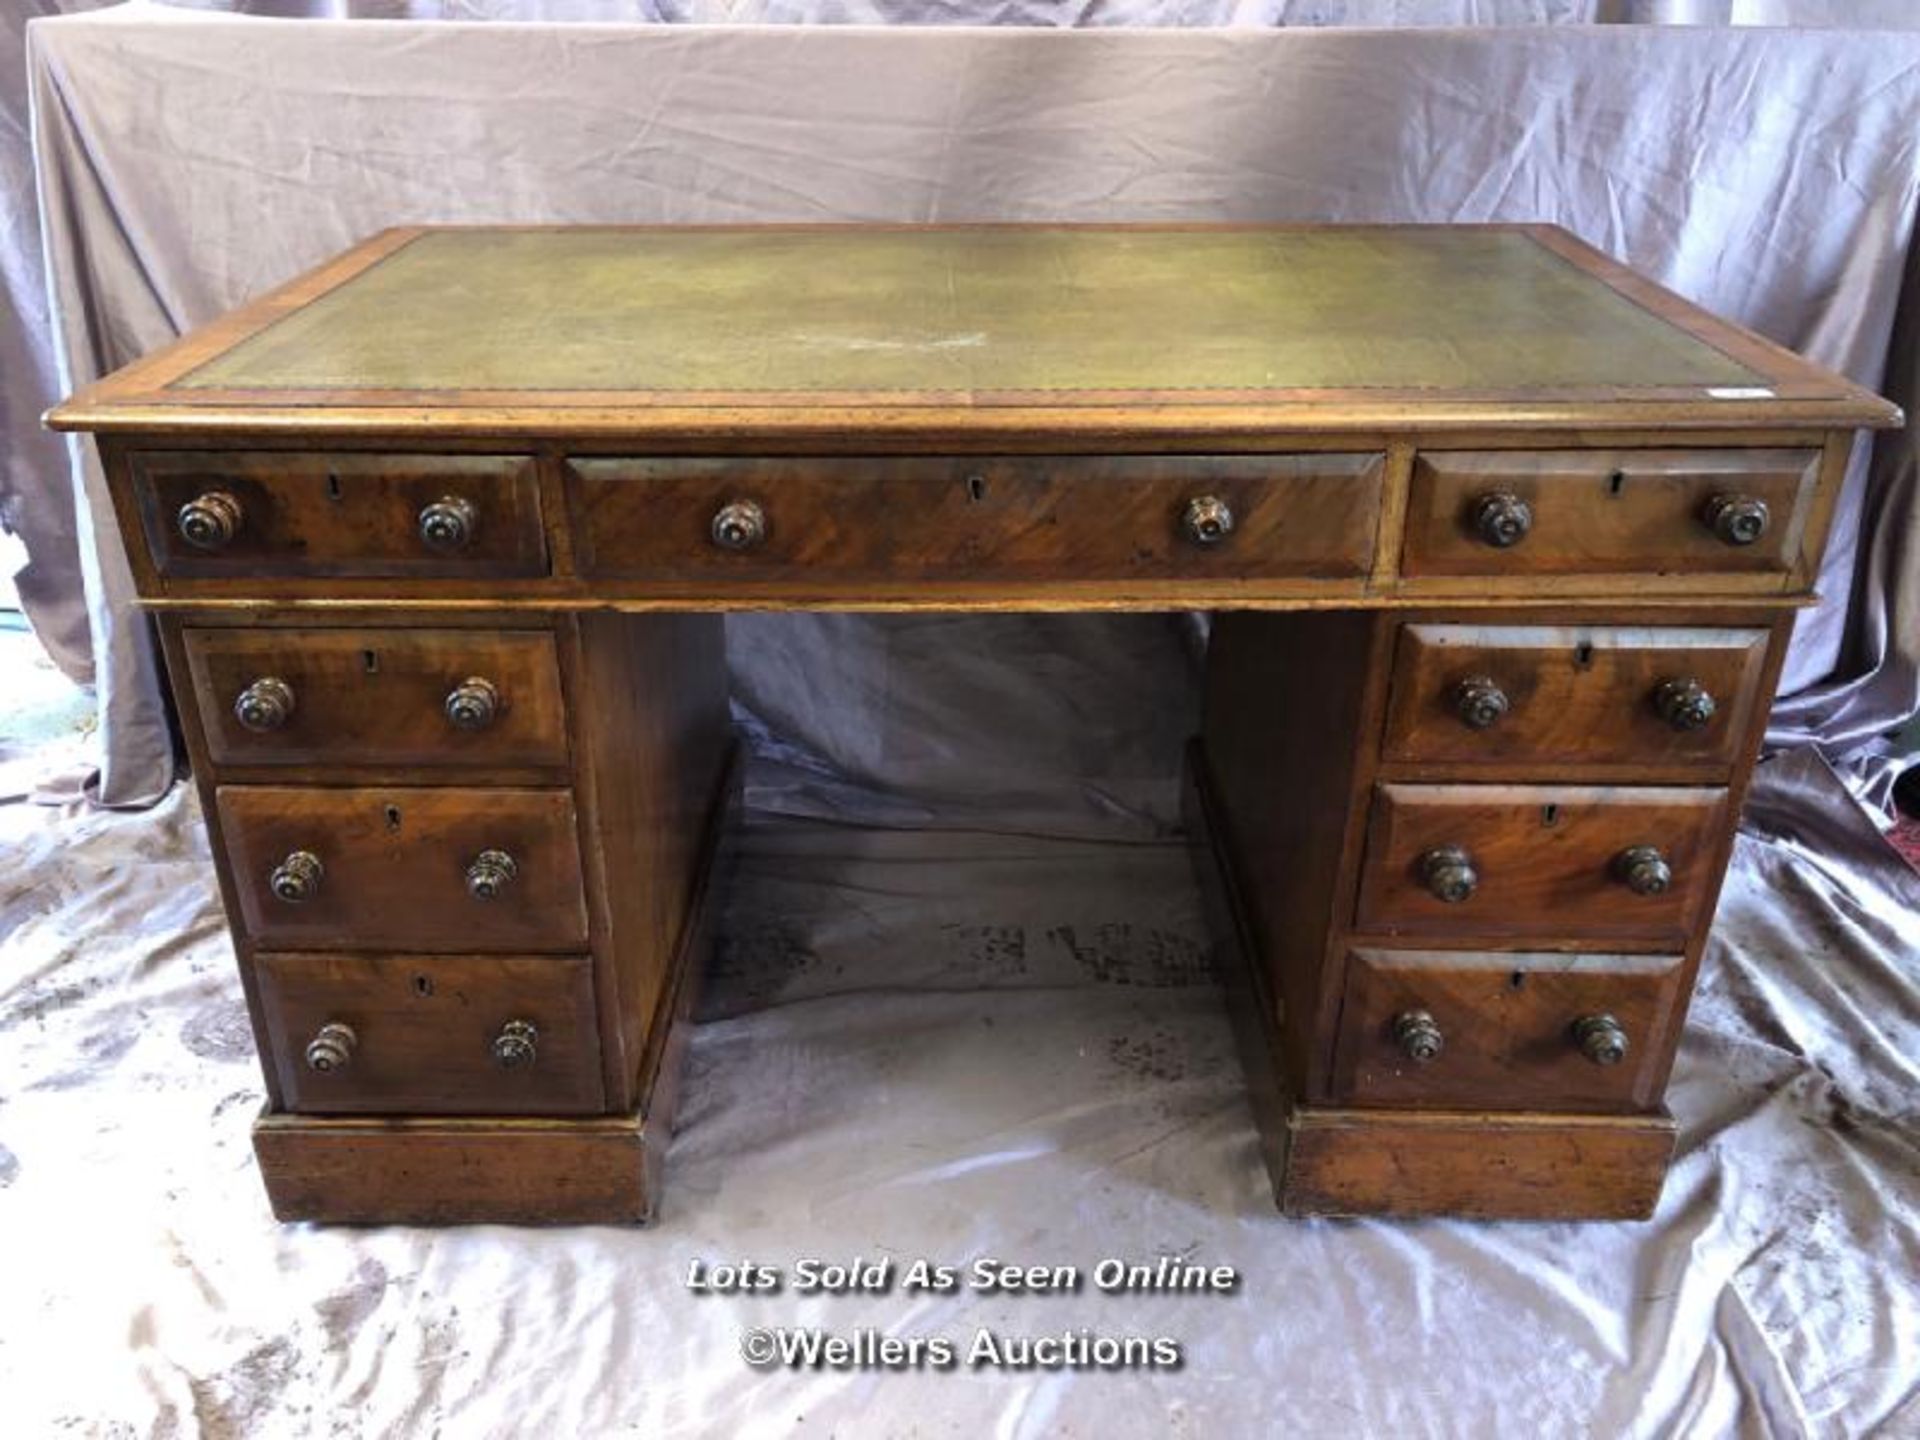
(1382, 624, 1766, 774)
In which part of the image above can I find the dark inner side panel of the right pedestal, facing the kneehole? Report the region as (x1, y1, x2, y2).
(1204, 614, 1380, 1094)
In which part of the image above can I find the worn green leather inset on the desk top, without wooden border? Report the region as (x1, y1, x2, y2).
(180, 228, 1764, 394)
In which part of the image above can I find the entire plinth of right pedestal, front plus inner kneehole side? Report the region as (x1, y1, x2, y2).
(1185, 745, 1674, 1219)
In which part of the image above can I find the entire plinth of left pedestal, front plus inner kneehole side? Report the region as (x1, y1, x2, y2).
(253, 753, 741, 1225)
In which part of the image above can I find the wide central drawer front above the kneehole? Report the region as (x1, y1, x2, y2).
(570, 455, 1382, 588)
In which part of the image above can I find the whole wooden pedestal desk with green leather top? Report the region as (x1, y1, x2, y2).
(50, 227, 1899, 1221)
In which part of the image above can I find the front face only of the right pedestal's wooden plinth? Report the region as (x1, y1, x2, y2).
(1281, 1108, 1674, 1219)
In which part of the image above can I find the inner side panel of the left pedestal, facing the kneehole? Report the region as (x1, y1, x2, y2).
(568, 612, 733, 1110)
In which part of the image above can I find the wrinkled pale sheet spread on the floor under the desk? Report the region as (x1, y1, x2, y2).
(0, 695, 1920, 1436)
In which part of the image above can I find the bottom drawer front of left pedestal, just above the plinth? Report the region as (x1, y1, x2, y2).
(255, 954, 603, 1116)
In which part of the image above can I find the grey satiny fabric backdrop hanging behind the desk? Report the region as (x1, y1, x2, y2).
(11, 0, 1920, 804)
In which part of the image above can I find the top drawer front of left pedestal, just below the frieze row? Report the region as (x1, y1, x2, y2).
(182, 628, 566, 766)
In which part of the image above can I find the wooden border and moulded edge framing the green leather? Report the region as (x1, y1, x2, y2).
(44, 223, 1903, 445)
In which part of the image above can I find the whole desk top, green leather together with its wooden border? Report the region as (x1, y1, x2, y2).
(48, 227, 1899, 440)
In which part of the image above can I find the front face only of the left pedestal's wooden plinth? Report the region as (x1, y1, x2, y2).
(253, 1116, 659, 1225)
